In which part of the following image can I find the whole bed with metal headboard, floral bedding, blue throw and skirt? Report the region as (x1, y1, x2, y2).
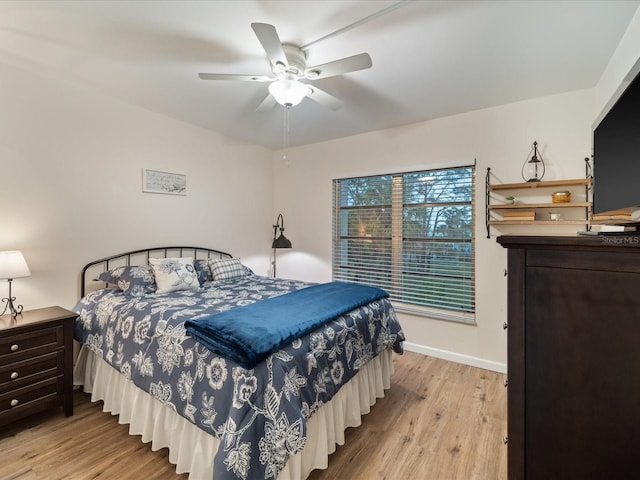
(74, 247, 404, 480)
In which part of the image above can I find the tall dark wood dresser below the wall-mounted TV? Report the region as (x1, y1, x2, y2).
(498, 236, 640, 480)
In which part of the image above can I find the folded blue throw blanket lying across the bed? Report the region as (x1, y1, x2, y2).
(185, 282, 389, 369)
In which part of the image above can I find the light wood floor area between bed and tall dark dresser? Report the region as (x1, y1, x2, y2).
(309, 352, 507, 480)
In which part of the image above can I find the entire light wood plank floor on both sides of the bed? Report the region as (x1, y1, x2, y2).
(0, 352, 507, 480)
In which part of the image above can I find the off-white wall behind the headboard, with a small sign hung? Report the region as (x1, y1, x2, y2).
(0, 65, 273, 309)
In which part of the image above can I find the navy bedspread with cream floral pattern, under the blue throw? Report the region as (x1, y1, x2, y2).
(74, 275, 404, 480)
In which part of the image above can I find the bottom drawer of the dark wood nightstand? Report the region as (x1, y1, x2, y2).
(0, 377, 63, 425)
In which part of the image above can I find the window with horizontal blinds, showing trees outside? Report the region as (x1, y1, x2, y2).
(333, 166, 475, 323)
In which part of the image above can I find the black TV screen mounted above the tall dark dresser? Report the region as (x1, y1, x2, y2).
(593, 68, 640, 214)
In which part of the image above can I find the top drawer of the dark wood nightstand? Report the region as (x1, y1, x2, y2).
(0, 325, 64, 365)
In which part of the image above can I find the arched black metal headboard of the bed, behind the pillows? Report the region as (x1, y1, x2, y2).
(80, 247, 232, 298)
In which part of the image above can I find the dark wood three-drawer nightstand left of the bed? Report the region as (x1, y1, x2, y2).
(0, 307, 78, 426)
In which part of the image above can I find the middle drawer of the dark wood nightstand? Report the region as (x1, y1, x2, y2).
(0, 351, 64, 394)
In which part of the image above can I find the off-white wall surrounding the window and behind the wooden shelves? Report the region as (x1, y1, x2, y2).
(273, 90, 593, 371)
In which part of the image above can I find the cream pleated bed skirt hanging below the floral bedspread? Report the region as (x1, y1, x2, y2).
(74, 347, 393, 480)
